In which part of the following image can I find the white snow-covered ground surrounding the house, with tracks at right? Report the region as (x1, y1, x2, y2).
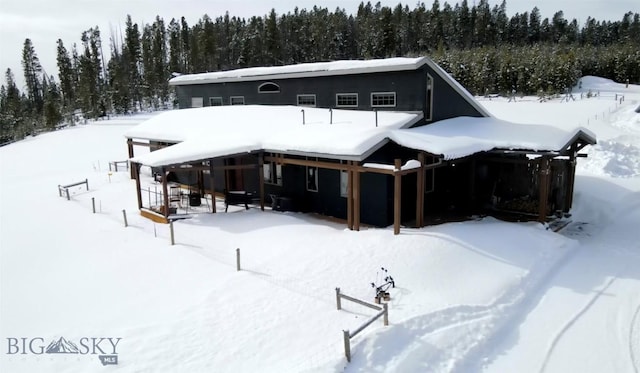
(0, 77, 640, 373)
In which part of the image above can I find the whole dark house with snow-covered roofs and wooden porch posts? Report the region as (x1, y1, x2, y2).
(126, 57, 596, 232)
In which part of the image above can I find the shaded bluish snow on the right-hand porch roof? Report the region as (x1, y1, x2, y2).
(389, 117, 596, 160)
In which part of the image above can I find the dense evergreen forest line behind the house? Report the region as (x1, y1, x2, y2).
(0, 0, 640, 143)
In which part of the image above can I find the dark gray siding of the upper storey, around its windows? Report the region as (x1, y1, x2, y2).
(176, 65, 481, 121)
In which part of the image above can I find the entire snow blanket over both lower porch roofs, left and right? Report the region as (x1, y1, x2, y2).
(125, 105, 595, 167)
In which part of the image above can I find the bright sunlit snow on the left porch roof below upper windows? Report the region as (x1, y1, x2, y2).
(125, 105, 422, 167)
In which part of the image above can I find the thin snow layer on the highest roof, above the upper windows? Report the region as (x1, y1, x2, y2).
(169, 57, 428, 85)
